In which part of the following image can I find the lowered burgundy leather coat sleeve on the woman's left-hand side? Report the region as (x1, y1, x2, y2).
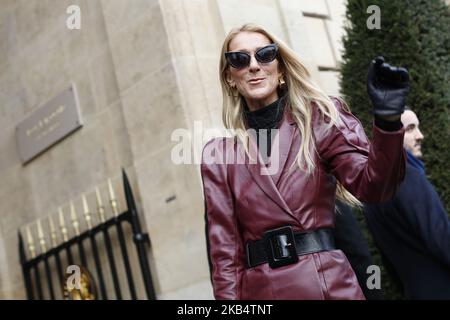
(201, 139, 245, 300)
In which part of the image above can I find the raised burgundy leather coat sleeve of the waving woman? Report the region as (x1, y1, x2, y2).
(313, 99, 406, 203)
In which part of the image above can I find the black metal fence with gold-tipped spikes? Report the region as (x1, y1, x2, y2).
(19, 170, 156, 300)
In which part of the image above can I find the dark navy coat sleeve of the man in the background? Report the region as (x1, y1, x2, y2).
(395, 167, 450, 268)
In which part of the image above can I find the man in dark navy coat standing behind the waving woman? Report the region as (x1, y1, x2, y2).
(364, 110, 450, 299)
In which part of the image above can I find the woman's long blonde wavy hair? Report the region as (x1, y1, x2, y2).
(219, 24, 361, 207)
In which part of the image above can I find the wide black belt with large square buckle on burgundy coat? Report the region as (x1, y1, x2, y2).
(246, 226, 335, 269)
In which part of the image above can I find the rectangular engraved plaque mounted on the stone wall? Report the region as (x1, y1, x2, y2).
(16, 84, 83, 163)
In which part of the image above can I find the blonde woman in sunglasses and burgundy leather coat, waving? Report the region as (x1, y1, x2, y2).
(201, 24, 409, 299)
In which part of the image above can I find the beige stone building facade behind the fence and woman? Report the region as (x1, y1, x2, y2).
(0, 0, 356, 299)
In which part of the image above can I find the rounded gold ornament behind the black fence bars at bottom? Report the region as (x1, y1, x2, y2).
(63, 266, 97, 300)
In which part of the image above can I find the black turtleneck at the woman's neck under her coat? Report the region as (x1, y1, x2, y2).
(244, 97, 285, 158)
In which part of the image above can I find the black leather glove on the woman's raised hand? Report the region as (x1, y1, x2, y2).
(367, 56, 409, 116)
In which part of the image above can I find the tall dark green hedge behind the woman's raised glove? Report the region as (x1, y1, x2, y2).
(341, 0, 450, 299)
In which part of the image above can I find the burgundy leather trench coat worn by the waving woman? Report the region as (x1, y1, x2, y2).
(201, 99, 405, 300)
